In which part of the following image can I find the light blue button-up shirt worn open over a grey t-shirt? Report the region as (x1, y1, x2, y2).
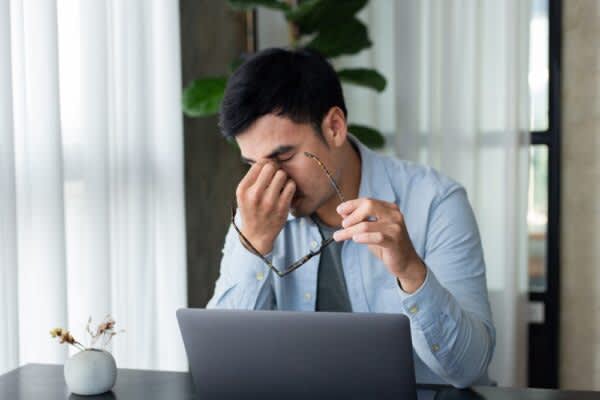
(207, 138, 496, 387)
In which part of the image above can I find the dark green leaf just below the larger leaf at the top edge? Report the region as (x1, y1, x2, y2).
(306, 18, 372, 58)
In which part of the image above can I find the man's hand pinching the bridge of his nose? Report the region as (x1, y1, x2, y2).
(236, 162, 296, 255)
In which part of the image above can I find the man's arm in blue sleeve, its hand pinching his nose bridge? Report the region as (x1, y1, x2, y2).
(207, 162, 296, 309)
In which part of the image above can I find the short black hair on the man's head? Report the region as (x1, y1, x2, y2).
(219, 48, 347, 139)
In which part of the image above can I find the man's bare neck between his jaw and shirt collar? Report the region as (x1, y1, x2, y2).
(315, 140, 362, 227)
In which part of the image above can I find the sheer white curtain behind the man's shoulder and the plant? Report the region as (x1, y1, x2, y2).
(258, 0, 531, 386)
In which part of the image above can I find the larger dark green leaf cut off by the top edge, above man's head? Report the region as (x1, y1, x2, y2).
(285, 0, 368, 34)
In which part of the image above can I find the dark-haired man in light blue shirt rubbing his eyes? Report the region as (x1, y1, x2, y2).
(207, 49, 495, 387)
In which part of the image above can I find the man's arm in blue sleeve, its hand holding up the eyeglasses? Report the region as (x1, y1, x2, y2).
(334, 185, 495, 387)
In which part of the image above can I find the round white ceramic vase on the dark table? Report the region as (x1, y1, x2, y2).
(64, 349, 117, 396)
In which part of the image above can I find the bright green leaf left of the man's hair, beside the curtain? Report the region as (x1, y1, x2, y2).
(182, 77, 227, 117)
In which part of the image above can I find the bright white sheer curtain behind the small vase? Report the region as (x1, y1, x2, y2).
(0, 0, 187, 373)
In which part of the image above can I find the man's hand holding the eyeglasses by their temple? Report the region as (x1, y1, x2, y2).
(333, 198, 427, 293)
